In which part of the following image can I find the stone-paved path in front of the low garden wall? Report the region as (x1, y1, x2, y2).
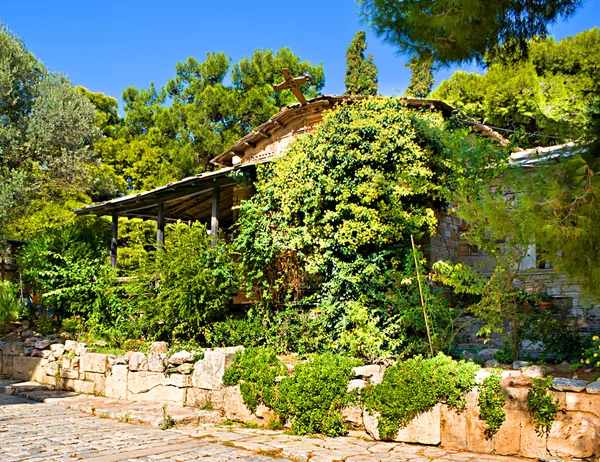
(0, 382, 526, 462)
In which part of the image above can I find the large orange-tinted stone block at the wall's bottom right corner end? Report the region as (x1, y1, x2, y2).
(548, 412, 600, 459)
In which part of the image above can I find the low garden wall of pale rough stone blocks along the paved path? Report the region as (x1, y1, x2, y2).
(0, 337, 600, 459)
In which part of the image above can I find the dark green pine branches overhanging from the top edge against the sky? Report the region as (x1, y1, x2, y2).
(359, 0, 582, 65)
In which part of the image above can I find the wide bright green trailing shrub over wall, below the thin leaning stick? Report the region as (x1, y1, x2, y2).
(364, 353, 479, 439)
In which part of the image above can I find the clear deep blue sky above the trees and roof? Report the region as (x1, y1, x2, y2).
(0, 0, 600, 108)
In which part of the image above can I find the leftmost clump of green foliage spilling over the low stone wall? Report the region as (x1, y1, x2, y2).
(223, 348, 287, 411)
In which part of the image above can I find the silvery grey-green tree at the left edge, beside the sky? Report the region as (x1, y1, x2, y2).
(0, 24, 99, 234)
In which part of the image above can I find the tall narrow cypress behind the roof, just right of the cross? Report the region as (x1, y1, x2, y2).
(344, 30, 377, 95)
